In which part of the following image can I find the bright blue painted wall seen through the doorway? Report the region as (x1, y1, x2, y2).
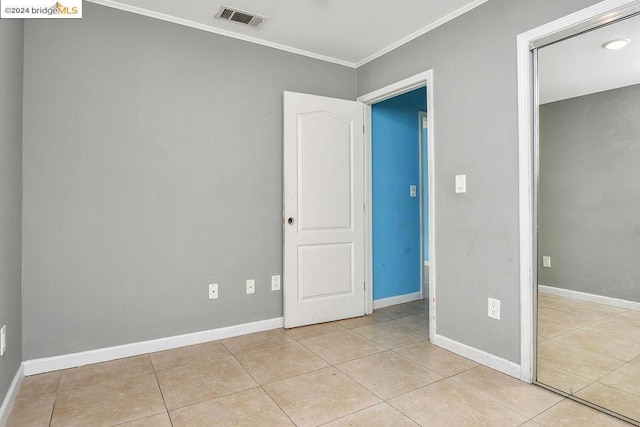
(371, 88, 427, 300)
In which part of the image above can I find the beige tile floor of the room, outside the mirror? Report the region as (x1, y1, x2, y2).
(8, 301, 625, 427)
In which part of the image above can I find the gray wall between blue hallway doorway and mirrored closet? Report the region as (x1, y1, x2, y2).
(358, 0, 596, 364)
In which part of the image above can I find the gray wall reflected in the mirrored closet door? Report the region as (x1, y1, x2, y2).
(538, 85, 640, 301)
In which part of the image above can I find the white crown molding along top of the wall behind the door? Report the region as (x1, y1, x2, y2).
(87, 0, 358, 68)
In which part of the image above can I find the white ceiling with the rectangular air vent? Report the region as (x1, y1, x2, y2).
(89, 0, 487, 67)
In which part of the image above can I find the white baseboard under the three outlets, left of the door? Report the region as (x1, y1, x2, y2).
(23, 317, 284, 376)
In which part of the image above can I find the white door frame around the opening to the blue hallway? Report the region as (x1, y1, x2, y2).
(358, 69, 436, 338)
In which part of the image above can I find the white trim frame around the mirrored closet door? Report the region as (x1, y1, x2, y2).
(516, 0, 640, 382)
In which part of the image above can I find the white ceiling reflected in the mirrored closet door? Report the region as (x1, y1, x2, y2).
(538, 16, 640, 104)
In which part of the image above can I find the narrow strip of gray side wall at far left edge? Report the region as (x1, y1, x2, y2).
(0, 19, 24, 405)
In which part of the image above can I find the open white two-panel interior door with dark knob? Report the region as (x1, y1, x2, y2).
(283, 92, 365, 328)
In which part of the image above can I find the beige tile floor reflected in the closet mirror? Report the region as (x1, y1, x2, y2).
(538, 294, 640, 422)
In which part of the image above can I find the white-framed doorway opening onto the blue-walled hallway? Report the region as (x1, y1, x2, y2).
(358, 70, 436, 337)
